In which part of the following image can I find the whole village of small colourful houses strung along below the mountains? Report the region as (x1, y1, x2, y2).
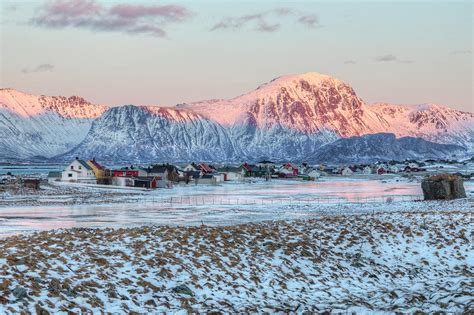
(10, 157, 462, 189)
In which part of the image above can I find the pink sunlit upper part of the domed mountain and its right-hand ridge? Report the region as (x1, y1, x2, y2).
(178, 72, 474, 150)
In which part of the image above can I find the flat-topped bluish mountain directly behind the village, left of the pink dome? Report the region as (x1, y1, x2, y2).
(60, 105, 238, 163)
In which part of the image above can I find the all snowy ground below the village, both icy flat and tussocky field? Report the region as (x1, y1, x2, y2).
(0, 176, 474, 314)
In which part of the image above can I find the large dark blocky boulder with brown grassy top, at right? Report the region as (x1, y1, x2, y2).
(421, 174, 466, 200)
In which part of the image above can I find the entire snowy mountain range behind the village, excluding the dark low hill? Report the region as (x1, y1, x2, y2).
(0, 73, 474, 162)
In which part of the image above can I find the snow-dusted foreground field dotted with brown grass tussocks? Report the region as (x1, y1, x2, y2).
(0, 209, 474, 313)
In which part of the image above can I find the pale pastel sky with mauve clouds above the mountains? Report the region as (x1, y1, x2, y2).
(0, 0, 474, 112)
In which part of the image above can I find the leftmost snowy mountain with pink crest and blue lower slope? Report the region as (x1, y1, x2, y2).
(0, 89, 107, 159)
